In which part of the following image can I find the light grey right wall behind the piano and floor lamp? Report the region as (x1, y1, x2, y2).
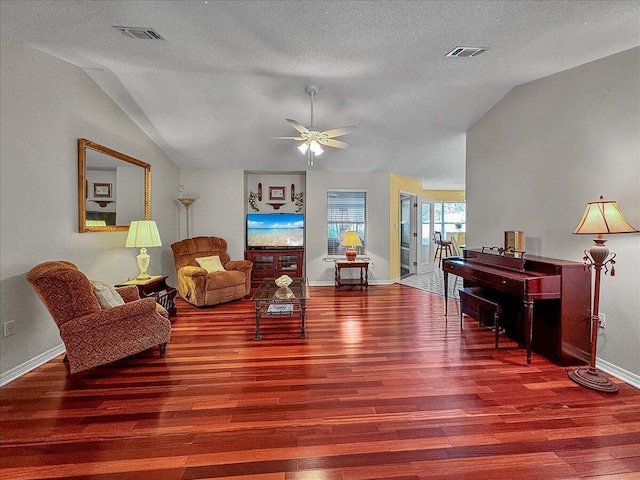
(466, 48, 640, 378)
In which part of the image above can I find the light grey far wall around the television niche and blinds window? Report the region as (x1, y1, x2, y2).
(180, 169, 389, 285)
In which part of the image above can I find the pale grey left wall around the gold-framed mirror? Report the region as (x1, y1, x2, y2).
(0, 37, 179, 378)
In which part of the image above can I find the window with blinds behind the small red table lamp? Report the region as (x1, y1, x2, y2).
(327, 190, 367, 256)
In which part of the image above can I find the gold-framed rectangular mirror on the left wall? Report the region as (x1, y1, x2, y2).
(78, 138, 151, 233)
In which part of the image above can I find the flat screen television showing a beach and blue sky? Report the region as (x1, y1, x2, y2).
(247, 213, 304, 249)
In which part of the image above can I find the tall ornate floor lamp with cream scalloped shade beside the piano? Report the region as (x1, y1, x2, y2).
(569, 196, 638, 392)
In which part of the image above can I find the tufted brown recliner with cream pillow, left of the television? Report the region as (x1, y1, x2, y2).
(171, 237, 253, 307)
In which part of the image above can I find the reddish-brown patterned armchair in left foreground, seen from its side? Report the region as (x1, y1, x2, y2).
(27, 261, 171, 375)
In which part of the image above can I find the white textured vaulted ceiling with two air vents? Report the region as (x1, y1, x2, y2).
(0, 0, 640, 189)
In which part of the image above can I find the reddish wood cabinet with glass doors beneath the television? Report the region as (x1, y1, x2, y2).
(244, 248, 304, 288)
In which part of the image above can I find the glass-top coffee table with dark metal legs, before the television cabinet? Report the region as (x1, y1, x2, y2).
(251, 278, 310, 340)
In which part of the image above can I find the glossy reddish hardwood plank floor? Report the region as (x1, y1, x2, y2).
(0, 285, 640, 480)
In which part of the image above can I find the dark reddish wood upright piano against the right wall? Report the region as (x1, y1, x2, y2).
(442, 249, 591, 365)
